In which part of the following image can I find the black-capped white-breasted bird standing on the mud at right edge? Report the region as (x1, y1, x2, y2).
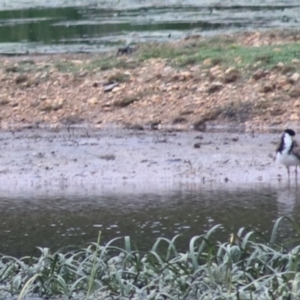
(275, 129, 300, 176)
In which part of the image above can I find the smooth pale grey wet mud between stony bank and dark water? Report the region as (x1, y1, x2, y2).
(0, 128, 287, 193)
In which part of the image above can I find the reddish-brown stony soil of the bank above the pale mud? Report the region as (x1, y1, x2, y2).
(0, 32, 300, 130)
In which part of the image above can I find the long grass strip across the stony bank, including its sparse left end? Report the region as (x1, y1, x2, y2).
(5, 37, 300, 73)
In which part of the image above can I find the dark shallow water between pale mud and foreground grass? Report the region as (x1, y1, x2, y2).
(0, 182, 300, 256)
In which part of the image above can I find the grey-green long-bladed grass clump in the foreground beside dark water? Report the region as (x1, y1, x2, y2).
(0, 218, 300, 299)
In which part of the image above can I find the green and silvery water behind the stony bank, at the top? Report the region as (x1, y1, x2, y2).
(0, 0, 300, 54)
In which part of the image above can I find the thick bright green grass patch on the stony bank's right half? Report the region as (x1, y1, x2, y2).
(138, 38, 300, 68)
